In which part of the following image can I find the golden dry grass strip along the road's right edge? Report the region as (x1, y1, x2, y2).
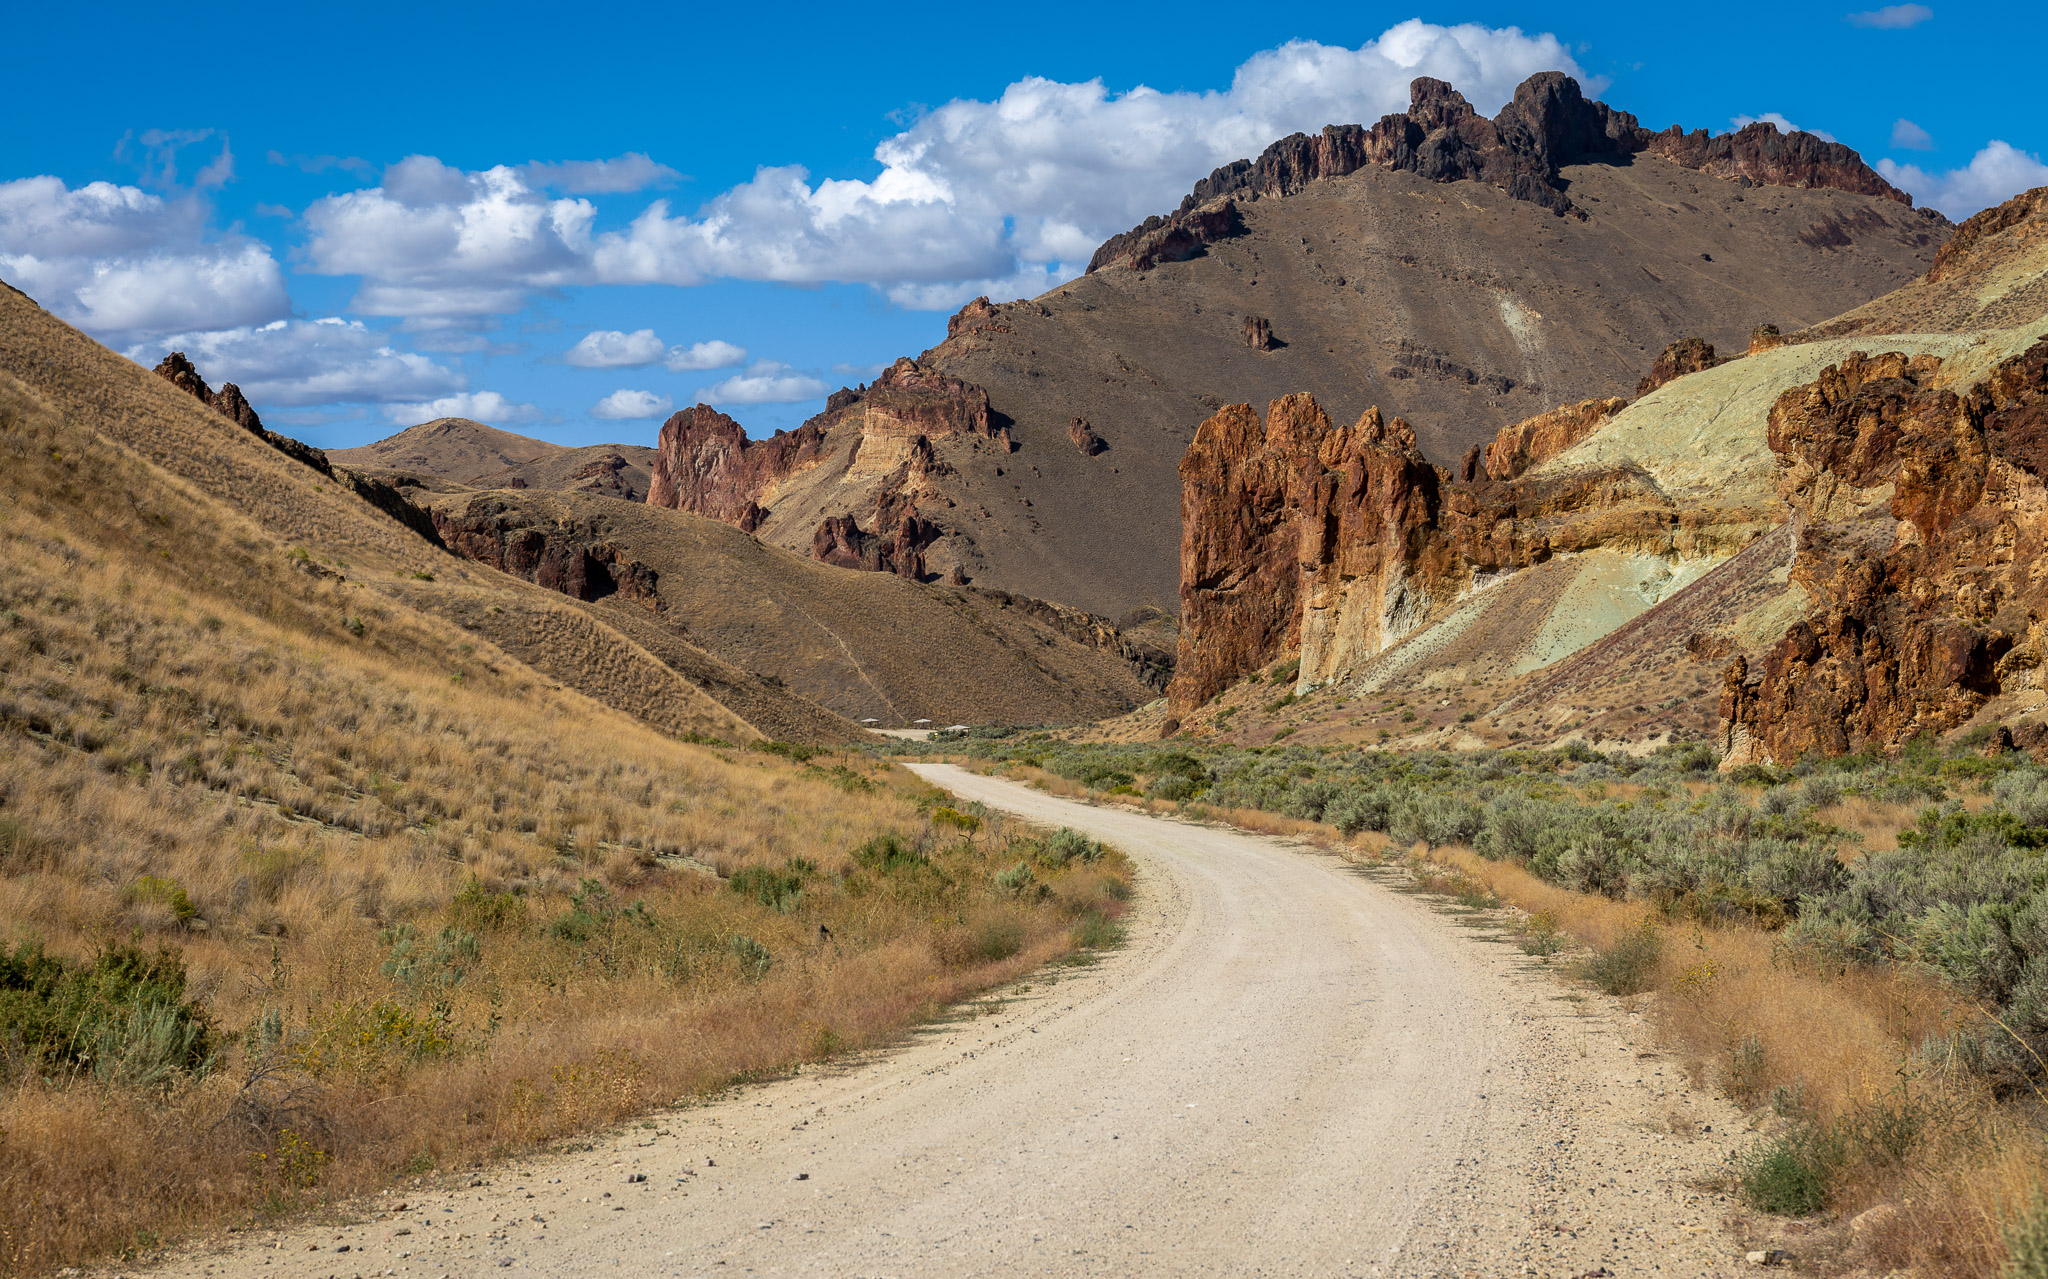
(1427, 843, 2048, 1279)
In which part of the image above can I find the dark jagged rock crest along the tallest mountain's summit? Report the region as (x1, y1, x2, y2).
(1087, 72, 1939, 270)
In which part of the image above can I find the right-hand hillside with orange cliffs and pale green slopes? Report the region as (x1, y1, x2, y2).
(1155, 182, 2048, 759)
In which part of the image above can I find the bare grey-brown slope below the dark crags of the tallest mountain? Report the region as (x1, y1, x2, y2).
(901, 156, 1944, 616)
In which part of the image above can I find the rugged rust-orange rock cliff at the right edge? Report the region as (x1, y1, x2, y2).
(1720, 340, 2048, 763)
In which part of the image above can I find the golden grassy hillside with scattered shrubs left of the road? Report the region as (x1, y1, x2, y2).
(0, 317, 1126, 1273)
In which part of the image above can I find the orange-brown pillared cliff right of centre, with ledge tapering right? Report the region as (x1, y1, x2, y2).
(1167, 378, 1755, 720)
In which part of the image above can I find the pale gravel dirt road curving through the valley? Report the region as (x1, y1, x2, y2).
(148, 765, 1741, 1279)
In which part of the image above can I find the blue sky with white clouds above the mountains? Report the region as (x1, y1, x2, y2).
(0, 2, 2048, 446)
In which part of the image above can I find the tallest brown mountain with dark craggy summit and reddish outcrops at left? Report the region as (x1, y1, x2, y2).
(647, 76, 1948, 616)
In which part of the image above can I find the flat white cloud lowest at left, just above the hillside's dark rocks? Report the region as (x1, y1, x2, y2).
(127, 319, 467, 413)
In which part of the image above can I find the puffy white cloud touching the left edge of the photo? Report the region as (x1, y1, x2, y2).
(0, 176, 291, 338)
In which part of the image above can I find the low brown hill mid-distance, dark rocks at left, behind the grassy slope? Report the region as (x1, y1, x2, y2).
(418, 491, 1157, 726)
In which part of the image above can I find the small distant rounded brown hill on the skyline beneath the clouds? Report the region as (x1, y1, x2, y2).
(328, 417, 653, 501)
